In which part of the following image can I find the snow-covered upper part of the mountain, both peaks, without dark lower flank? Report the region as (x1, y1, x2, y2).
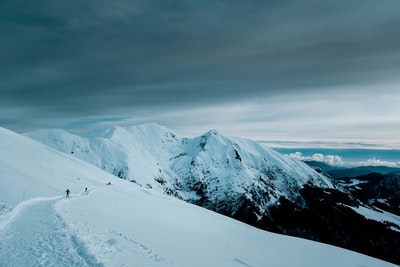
(26, 123, 332, 220)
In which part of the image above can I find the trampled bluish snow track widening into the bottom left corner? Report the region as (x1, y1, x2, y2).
(0, 198, 104, 267)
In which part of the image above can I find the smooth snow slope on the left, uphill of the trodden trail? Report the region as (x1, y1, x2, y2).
(0, 128, 115, 206)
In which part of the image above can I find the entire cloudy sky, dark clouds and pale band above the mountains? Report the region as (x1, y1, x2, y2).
(0, 0, 400, 147)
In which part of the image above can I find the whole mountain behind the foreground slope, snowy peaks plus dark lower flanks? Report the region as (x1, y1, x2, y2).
(26, 124, 400, 263)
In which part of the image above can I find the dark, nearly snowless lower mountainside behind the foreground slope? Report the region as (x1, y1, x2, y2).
(183, 170, 400, 264)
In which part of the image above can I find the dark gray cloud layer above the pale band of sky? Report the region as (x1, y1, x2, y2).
(0, 0, 400, 139)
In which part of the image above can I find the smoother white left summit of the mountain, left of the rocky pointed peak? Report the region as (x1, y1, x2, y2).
(26, 124, 178, 186)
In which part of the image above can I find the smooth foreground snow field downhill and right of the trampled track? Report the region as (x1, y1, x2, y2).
(56, 180, 393, 267)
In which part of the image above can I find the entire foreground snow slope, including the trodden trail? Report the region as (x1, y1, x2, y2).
(0, 128, 395, 267)
